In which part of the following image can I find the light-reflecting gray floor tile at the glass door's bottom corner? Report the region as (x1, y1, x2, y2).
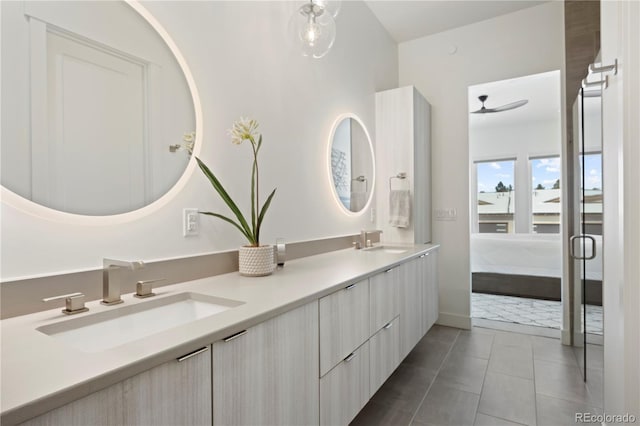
(534, 359, 595, 405)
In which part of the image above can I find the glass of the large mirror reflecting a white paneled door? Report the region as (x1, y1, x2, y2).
(0, 1, 196, 216)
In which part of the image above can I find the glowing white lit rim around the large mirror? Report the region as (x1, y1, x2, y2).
(0, 0, 203, 226)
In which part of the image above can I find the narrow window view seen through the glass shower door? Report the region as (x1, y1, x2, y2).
(580, 152, 602, 235)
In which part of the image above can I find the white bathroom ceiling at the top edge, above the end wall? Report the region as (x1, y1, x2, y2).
(365, 0, 545, 43)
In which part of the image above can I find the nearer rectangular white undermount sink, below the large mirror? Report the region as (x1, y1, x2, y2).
(37, 292, 244, 352)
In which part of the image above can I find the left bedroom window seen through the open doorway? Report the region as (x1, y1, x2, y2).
(476, 160, 516, 233)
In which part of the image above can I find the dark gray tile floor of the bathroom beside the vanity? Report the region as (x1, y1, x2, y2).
(352, 325, 603, 426)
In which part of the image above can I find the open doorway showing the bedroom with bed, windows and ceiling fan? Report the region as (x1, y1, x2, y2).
(468, 70, 563, 337)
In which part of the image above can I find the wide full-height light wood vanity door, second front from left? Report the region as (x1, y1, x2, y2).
(213, 301, 320, 426)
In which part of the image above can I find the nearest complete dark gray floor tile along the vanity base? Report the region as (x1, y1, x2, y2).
(371, 363, 436, 415)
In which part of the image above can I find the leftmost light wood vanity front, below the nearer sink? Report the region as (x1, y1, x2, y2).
(22, 346, 211, 426)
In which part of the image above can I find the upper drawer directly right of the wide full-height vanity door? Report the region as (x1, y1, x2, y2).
(320, 280, 369, 376)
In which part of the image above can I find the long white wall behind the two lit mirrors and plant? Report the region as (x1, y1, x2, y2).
(1, 1, 398, 285)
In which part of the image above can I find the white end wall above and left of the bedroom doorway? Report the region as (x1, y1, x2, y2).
(398, 2, 564, 327)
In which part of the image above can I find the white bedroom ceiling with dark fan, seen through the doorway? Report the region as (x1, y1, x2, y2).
(469, 71, 561, 128)
